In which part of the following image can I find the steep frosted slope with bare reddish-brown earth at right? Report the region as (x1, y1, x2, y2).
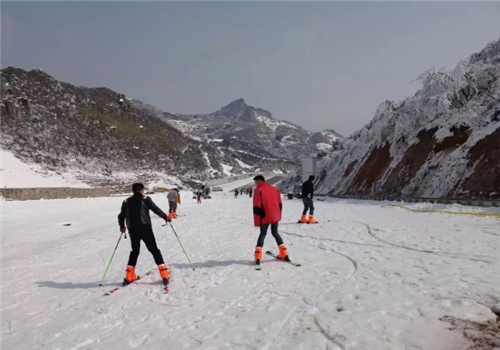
(318, 40, 500, 199)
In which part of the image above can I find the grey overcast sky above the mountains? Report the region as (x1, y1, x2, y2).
(1, 2, 500, 135)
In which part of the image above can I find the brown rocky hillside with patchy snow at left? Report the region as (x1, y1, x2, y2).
(1, 67, 227, 185)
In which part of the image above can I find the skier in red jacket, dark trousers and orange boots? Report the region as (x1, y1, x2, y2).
(253, 175, 290, 265)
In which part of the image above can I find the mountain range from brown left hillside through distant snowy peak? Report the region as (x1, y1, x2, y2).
(0, 67, 339, 185)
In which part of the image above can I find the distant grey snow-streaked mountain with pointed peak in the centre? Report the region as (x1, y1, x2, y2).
(164, 99, 342, 170)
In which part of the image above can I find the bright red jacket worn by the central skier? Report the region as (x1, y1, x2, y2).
(253, 182, 283, 227)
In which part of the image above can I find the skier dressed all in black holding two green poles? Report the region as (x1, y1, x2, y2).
(118, 183, 172, 285)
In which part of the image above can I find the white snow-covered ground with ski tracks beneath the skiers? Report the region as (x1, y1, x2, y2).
(1, 193, 500, 350)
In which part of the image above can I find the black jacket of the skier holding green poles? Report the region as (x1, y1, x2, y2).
(118, 193, 167, 230)
